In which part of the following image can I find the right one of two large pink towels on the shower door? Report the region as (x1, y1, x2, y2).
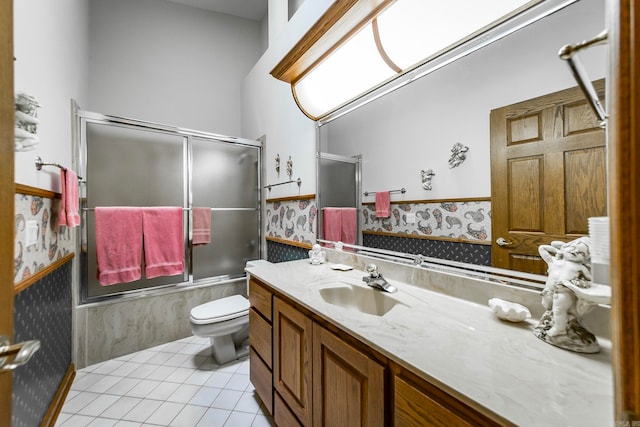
(142, 206, 184, 279)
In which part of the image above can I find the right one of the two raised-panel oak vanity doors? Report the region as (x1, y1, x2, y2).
(313, 324, 385, 427)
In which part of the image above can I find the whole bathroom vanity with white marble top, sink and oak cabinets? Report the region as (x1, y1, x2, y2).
(247, 252, 613, 426)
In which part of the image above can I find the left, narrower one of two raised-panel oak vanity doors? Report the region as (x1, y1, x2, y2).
(273, 297, 313, 426)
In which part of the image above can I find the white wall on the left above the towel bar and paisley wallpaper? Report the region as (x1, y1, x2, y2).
(13, 0, 89, 192)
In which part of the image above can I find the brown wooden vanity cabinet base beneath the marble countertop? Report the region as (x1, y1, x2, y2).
(249, 279, 513, 427)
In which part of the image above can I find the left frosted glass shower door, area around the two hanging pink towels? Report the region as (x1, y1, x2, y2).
(83, 122, 188, 298)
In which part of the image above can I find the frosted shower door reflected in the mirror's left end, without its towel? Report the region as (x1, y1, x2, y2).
(316, 153, 362, 245)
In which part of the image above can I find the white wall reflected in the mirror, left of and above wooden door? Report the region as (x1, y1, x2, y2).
(321, 0, 607, 201)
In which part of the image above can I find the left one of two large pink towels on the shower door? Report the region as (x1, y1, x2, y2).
(95, 207, 142, 286)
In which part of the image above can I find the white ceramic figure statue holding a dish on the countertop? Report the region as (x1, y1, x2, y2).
(534, 237, 610, 353)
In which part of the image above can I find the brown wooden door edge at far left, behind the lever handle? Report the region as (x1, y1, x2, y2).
(0, 0, 15, 426)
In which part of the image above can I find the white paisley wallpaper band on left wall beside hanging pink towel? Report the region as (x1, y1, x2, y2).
(13, 194, 74, 284)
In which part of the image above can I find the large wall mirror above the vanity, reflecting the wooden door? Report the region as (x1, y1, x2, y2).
(318, 0, 609, 280)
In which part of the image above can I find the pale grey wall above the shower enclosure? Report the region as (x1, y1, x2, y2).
(88, 0, 264, 136)
